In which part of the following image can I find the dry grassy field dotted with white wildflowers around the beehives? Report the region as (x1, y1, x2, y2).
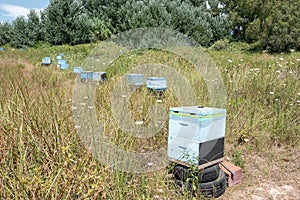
(0, 44, 300, 199)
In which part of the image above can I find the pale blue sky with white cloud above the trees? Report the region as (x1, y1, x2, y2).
(0, 0, 50, 22)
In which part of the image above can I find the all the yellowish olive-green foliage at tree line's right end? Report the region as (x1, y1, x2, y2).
(224, 0, 300, 52)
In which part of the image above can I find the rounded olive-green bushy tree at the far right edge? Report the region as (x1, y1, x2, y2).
(245, 1, 300, 52)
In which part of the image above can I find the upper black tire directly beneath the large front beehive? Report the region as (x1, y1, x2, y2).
(174, 164, 220, 183)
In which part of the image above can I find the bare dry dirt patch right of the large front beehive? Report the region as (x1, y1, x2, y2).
(220, 148, 300, 200)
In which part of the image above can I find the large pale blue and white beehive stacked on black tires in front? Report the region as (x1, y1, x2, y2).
(168, 106, 226, 167)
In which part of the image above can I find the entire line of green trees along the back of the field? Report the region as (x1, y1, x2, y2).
(0, 0, 300, 52)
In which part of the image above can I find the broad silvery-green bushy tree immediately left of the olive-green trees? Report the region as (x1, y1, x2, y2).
(117, 0, 229, 46)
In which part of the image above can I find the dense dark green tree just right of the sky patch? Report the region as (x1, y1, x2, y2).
(42, 0, 95, 45)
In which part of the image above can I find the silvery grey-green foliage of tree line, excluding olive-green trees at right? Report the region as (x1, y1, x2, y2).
(3, 0, 229, 48)
